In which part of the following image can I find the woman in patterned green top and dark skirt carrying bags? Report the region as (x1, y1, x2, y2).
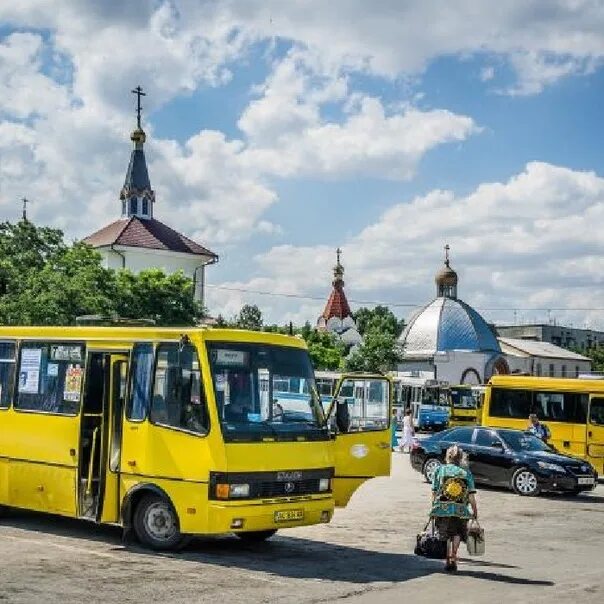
(431, 445, 478, 571)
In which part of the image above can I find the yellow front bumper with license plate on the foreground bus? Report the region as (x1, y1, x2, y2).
(203, 496, 334, 534)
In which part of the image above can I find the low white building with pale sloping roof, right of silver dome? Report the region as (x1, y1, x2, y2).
(498, 337, 592, 378)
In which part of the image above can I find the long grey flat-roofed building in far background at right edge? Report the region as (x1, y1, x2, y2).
(495, 323, 604, 350)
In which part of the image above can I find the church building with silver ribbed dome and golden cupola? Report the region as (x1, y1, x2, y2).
(397, 246, 509, 384)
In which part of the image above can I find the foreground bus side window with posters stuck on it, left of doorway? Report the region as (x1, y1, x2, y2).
(15, 342, 85, 415)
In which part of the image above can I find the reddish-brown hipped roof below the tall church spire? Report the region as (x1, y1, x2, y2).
(84, 216, 218, 259)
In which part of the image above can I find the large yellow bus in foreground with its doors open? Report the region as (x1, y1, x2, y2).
(0, 326, 392, 549)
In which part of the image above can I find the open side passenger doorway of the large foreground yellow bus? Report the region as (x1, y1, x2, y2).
(77, 351, 128, 522)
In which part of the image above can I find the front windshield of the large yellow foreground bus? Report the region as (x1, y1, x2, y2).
(208, 342, 329, 442)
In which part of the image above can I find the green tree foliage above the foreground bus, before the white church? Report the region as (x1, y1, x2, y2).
(0, 221, 202, 325)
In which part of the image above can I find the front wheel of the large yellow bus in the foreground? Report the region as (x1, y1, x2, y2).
(133, 494, 182, 550)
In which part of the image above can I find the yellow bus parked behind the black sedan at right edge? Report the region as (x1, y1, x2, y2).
(482, 376, 604, 476)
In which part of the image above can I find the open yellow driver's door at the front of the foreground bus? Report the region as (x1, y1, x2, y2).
(330, 375, 392, 507)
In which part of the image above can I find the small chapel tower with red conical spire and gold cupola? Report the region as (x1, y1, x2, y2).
(317, 248, 363, 352)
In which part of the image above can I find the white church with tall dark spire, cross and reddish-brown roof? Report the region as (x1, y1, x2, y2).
(84, 86, 218, 305)
